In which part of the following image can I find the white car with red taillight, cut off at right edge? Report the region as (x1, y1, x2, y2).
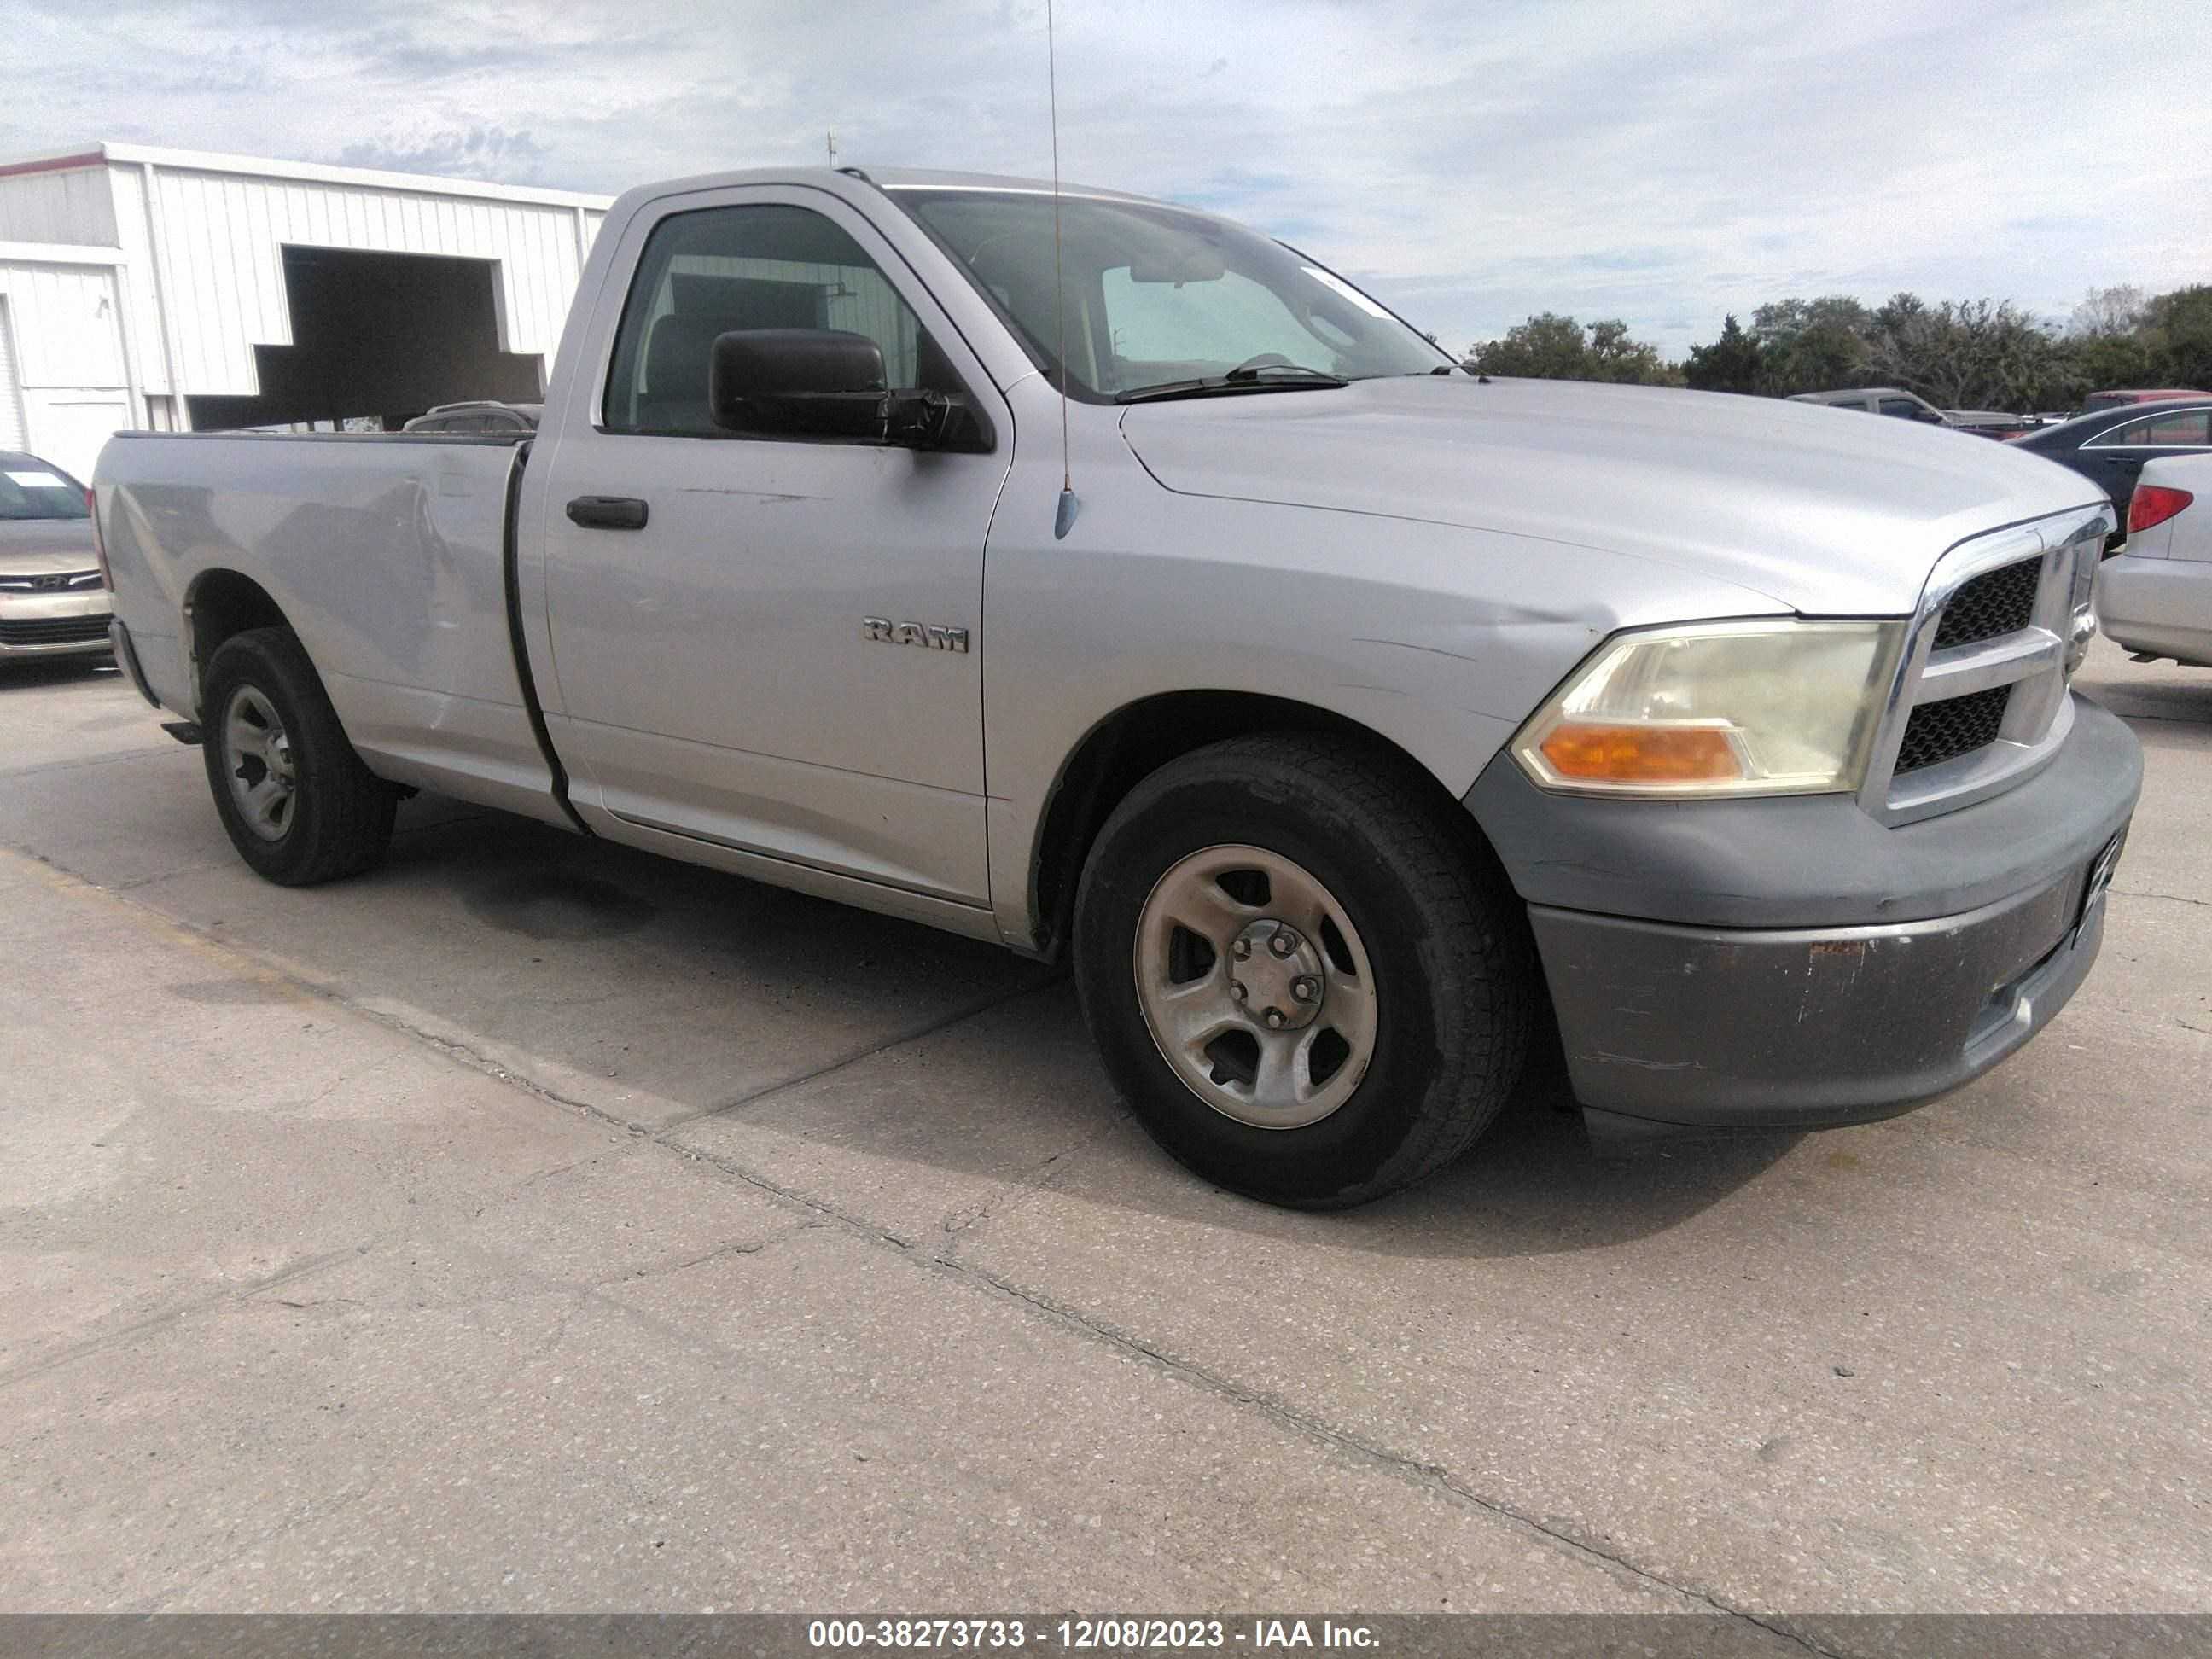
(2097, 456, 2212, 668)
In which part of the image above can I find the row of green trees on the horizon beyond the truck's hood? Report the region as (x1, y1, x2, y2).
(1466, 283, 2212, 411)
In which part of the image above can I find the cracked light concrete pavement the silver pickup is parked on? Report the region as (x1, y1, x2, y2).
(0, 646, 2212, 1645)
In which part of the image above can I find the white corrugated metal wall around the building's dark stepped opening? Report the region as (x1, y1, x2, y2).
(144, 166, 599, 396)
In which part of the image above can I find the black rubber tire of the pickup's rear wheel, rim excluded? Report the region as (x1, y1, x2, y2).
(199, 628, 399, 887)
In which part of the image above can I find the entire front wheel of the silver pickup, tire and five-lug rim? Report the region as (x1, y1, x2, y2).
(1075, 736, 1535, 1210)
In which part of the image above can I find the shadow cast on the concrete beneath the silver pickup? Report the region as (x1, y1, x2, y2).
(21, 760, 1787, 1256)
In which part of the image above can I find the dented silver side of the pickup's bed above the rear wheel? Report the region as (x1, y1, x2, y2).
(100, 431, 567, 823)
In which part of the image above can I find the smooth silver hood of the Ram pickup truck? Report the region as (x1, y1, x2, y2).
(1121, 376, 2101, 615)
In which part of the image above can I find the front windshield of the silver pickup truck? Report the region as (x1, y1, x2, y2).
(892, 188, 1453, 403)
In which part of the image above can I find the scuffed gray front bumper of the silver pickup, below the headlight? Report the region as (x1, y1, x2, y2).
(1466, 703, 2141, 1131)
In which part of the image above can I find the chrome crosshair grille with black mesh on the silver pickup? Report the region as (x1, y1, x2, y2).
(1860, 507, 2112, 823)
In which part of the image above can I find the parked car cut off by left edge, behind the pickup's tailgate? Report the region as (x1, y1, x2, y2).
(0, 449, 108, 657)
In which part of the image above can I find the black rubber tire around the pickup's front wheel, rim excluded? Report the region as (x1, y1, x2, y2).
(1073, 735, 1537, 1210)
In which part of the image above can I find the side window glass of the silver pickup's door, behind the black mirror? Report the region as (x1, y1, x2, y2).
(604, 203, 942, 436)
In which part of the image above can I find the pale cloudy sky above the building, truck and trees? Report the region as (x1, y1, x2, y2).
(0, 0, 2212, 356)
